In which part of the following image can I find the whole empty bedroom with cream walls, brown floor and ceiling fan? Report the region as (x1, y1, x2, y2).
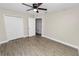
(0, 3, 79, 56)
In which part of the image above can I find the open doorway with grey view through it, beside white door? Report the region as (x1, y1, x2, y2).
(36, 18, 42, 36)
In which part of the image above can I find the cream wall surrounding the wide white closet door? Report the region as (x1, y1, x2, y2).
(0, 9, 29, 43)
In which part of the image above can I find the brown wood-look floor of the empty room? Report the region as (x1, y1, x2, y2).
(0, 36, 78, 56)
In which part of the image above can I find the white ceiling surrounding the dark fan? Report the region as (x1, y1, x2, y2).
(0, 3, 79, 13)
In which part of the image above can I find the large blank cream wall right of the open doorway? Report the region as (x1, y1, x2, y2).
(43, 8, 79, 48)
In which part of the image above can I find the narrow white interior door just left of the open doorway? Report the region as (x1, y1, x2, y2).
(28, 18, 35, 36)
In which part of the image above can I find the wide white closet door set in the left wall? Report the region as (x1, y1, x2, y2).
(4, 16, 24, 40)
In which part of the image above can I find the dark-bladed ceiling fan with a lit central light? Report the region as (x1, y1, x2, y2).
(22, 3, 47, 13)
